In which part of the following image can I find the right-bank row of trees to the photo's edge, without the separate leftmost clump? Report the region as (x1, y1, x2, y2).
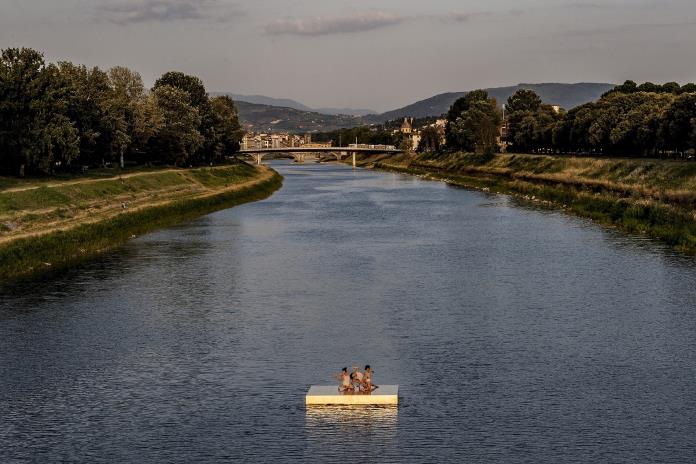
(506, 82, 696, 157)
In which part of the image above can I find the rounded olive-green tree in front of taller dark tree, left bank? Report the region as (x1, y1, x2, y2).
(150, 85, 204, 166)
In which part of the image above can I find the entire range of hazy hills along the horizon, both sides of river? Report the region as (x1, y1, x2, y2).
(228, 83, 615, 133)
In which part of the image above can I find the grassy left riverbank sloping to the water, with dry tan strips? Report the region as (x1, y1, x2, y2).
(0, 164, 282, 280)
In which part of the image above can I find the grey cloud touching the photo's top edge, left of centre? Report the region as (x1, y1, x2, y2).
(100, 0, 241, 24)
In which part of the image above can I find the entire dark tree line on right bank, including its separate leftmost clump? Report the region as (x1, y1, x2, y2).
(446, 81, 696, 158)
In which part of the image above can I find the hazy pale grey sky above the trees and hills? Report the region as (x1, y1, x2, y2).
(0, 0, 696, 111)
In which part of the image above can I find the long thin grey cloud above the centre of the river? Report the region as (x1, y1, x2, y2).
(266, 11, 407, 36)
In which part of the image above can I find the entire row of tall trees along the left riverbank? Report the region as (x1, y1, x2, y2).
(0, 48, 243, 175)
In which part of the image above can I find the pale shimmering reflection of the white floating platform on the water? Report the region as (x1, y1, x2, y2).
(305, 406, 398, 458)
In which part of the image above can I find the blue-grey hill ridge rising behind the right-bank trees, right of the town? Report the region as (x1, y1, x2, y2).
(369, 83, 615, 122)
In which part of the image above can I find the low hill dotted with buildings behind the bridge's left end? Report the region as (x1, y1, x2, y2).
(235, 100, 366, 133)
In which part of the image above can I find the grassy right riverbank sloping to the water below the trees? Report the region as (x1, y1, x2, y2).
(359, 153, 696, 254)
